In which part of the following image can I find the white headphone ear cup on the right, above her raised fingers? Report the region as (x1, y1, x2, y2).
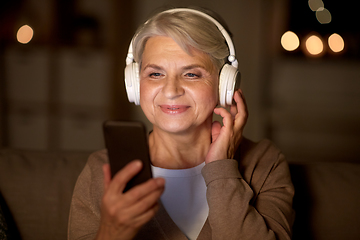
(219, 64, 240, 107)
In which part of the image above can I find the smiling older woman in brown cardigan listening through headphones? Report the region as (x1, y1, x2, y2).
(69, 9, 294, 240)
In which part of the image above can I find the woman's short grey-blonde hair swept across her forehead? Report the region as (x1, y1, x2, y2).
(133, 8, 229, 70)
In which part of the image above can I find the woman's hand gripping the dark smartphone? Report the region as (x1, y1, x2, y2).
(96, 160, 165, 240)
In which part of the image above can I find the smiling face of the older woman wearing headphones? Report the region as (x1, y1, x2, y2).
(140, 36, 218, 133)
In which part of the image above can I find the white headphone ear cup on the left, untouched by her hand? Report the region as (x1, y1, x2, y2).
(125, 62, 140, 105)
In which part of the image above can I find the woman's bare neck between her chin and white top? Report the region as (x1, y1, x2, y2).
(149, 126, 211, 169)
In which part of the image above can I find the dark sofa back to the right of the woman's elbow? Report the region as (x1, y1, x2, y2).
(290, 162, 360, 240)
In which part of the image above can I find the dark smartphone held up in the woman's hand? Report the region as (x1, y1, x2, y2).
(103, 120, 152, 192)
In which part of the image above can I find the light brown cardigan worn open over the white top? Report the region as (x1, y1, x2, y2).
(68, 139, 294, 240)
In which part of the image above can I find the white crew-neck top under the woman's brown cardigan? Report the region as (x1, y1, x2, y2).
(151, 163, 209, 240)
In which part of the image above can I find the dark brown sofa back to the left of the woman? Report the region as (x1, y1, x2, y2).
(0, 150, 89, 240)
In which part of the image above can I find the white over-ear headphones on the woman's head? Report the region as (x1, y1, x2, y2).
(125, 8, 240, 107)
